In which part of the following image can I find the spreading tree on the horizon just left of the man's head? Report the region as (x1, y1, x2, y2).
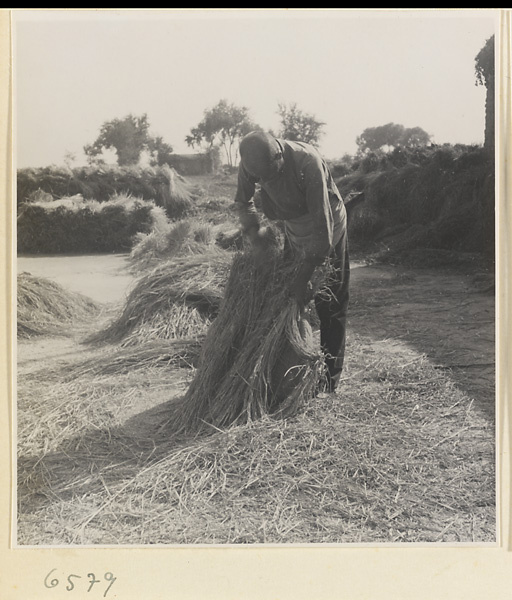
(185, 100, 261, 166)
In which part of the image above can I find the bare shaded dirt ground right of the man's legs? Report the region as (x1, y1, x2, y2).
(348, 265, 495, 419)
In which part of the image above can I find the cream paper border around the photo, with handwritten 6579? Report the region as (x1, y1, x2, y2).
(0, 9, 512, 600)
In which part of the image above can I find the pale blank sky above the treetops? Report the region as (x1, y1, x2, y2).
(13, 9, 499, 168)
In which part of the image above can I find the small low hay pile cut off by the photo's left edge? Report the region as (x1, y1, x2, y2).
(17, 273, 99, 339)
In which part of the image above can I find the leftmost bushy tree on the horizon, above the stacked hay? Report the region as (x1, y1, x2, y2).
(84, 114, 172, 166)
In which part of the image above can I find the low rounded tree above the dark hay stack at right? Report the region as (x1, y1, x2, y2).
(356, 123, 431, 154)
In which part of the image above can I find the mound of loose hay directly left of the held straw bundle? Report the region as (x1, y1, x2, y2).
(86, 249, 231, 346)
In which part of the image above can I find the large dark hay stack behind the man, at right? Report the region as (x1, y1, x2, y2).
(336, 147, 494, 257)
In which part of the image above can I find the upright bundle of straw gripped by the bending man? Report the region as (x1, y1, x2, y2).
(169, 241, 324, 432)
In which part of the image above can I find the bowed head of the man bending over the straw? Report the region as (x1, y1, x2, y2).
(240, 131, 284, 183)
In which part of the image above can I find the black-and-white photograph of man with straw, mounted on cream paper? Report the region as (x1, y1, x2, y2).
(11, 9, 500, 552)
